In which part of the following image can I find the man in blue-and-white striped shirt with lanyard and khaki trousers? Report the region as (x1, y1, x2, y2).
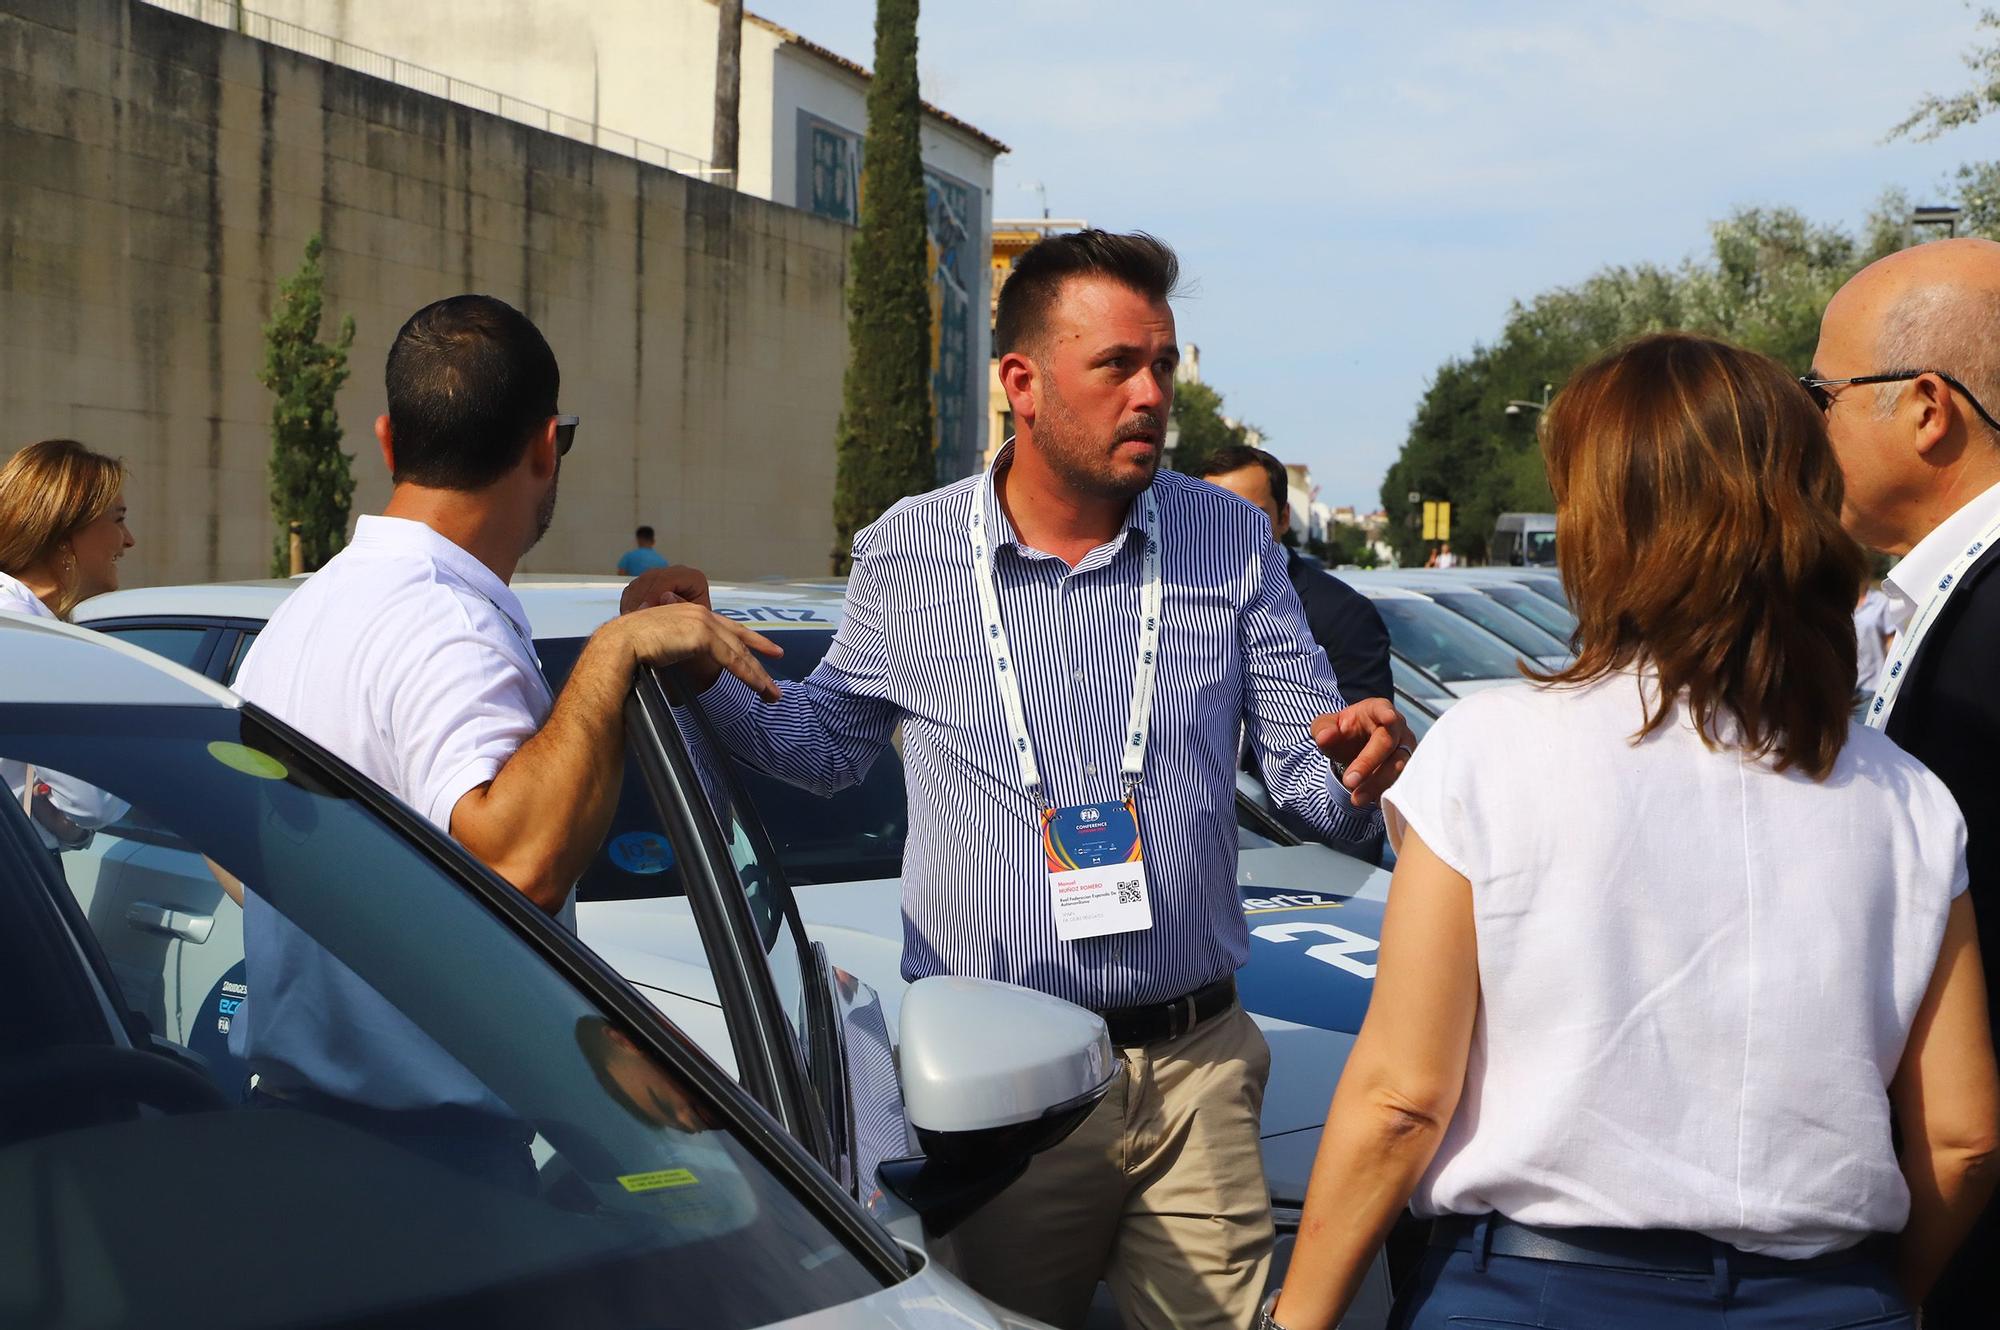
(656, 230, 1408, 1328)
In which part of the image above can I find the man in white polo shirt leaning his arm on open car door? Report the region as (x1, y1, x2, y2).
(230, 296, 778, 1162)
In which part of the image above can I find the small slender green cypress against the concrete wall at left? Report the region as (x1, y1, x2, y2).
(258, 236, 354, 576)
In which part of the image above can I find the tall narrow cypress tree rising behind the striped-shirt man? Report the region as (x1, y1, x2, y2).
(832, 0, 938, 574)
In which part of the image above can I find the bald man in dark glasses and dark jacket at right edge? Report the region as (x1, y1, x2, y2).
(1800, 238, 2000, 1330)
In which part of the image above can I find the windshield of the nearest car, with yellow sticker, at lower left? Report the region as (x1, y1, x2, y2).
(0, 706, 880, 1328)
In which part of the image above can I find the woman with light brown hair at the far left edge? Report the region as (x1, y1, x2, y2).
(0, 438, 132, 620)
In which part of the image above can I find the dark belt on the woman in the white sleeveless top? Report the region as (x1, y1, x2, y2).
(1430, 1214, 1882, 1274)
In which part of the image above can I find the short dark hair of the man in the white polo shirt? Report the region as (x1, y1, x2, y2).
(384, 296, 562, 490)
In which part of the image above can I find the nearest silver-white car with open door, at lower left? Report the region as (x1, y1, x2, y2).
(0, 614, 1118, 1330)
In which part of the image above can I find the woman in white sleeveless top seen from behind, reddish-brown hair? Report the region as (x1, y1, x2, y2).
(1264, 334, 2000, 1330)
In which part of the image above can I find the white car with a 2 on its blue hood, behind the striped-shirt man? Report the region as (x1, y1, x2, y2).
(78, 576, 1408, 1328)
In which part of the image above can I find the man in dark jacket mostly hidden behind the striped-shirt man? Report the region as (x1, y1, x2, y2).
(1190, 444, 1394, 864)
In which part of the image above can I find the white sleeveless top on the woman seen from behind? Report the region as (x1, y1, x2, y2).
(1384, 672, 1966, 1258)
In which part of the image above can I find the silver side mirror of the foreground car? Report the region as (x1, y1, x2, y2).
(880, 976, 1120, 1236)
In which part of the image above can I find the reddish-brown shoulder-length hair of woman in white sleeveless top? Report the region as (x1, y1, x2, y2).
(1538, 332, 1866, 778)
